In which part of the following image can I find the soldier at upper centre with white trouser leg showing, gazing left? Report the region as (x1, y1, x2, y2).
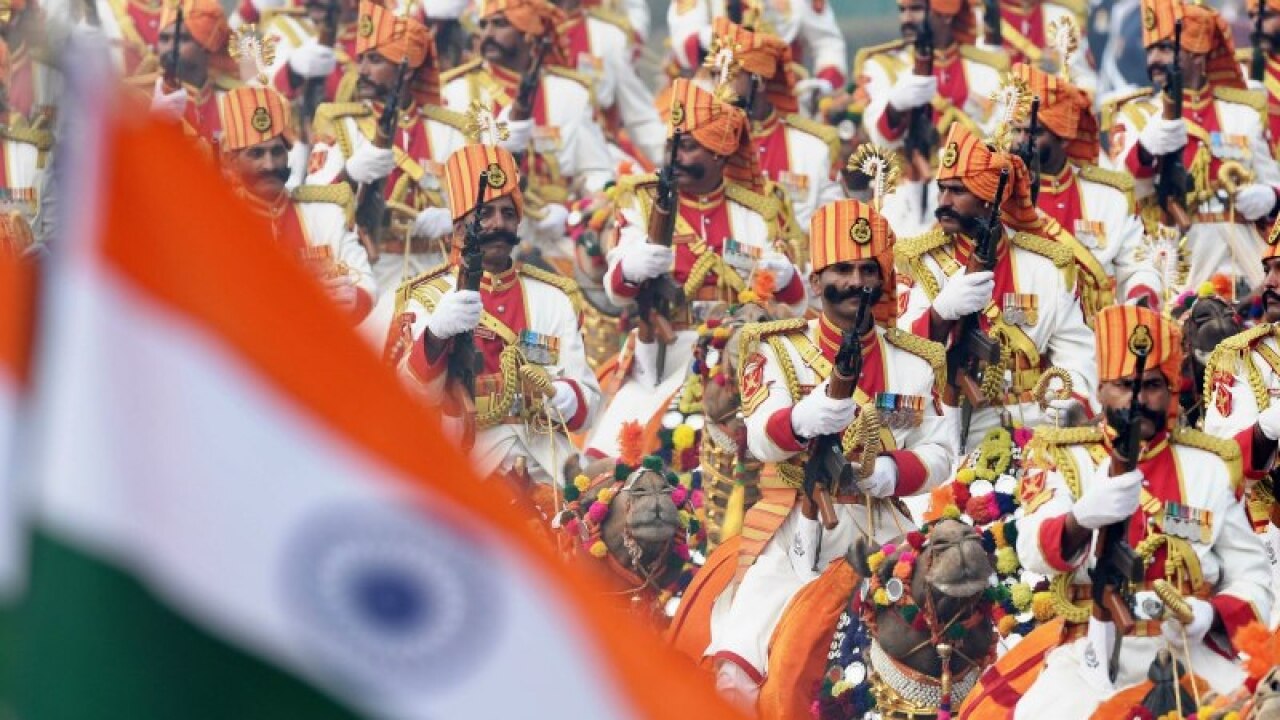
(586, 78, 806, 456)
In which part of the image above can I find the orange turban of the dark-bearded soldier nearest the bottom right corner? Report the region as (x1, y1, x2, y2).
(1094, 305, 1183, 389)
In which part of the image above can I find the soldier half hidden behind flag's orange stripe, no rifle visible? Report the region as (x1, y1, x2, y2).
(218, 86, 375, 319)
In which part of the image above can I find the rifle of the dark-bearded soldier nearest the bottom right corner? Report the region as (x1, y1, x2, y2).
(1089, 325, 1152, 682)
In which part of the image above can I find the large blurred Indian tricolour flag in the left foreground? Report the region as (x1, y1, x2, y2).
(0, 77, 732, 719)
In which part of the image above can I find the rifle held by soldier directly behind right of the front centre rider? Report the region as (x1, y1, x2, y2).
(942, 168, 1009, 454)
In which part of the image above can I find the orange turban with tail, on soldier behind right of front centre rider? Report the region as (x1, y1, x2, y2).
(937, 123, 1042, 232)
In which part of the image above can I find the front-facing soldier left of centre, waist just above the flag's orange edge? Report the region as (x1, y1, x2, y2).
(389, 137, 600, 484)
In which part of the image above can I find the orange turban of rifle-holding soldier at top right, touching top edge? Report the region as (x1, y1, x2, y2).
(1142, 0, 1244, 88)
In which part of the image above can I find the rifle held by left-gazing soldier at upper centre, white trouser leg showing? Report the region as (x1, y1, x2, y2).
(636, 129, 685, 384)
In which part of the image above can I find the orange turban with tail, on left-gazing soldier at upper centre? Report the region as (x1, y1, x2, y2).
(667, 78, 759, 187)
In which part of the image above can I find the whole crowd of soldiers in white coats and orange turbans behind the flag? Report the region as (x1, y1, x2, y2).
(17, 0, 1280, 720)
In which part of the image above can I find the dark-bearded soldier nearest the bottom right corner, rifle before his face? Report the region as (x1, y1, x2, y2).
(1014, 305, 1272, 720)
